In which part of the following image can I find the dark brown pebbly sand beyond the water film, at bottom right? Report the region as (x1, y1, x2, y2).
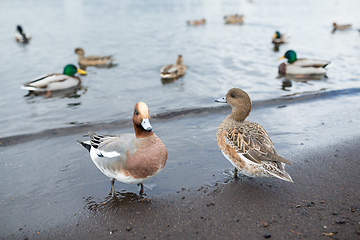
(19, 138, 360, 239)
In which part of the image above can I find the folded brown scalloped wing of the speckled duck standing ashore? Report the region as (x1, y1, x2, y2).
(225, 122, 291, 165)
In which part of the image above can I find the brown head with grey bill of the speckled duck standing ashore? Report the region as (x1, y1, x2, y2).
(215, 88, 252, 121)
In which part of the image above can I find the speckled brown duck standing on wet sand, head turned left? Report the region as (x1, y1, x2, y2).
(215, 88, 293, 182)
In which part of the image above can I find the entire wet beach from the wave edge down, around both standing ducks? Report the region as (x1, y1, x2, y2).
(0, 93, 360, 239)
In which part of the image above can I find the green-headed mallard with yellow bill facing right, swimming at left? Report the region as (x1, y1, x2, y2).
(21, 64, 86, 97)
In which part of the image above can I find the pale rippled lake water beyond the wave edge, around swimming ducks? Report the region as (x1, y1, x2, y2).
(0, 0, 360, 137)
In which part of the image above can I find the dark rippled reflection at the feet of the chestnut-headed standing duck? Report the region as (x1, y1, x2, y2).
(85, 192, 151, 214)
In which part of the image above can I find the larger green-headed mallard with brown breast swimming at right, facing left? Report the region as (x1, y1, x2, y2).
(278, 50, 331, 76)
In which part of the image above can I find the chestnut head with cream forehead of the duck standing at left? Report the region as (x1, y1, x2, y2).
(133, 102, 152, 133)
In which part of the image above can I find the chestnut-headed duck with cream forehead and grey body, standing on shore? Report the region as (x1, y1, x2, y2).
(78, 102, 167, 196)
